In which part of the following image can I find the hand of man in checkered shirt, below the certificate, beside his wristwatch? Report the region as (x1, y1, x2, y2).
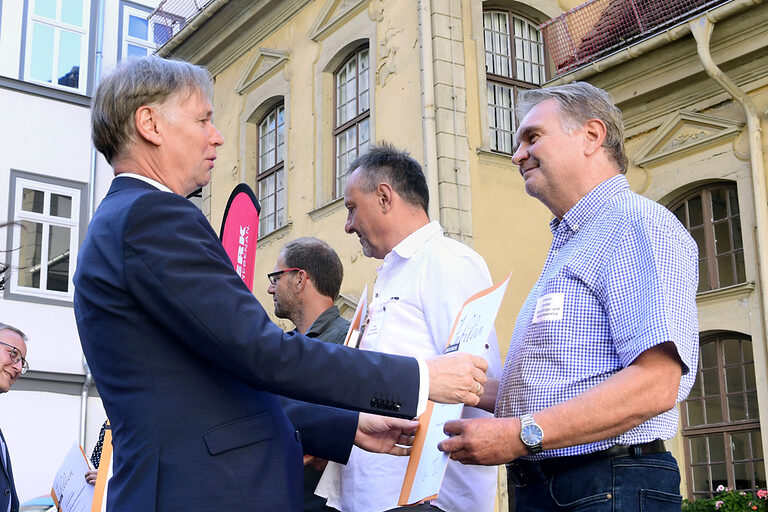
(437, 418, 527, 466)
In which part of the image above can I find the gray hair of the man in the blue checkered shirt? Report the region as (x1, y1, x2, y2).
(516, 82, 627, 174)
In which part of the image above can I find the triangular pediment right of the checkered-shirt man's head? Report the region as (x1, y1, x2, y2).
(634, 111, 744, 167)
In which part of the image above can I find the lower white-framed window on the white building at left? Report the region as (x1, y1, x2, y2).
(9, 177, 81, 300)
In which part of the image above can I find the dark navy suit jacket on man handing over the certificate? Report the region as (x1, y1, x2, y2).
(75, 177, 419, 512)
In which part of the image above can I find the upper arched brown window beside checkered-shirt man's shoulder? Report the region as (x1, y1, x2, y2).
(670, 183, 747, 292)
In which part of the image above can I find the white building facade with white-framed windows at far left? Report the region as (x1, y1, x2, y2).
(0, 0, 170, 501)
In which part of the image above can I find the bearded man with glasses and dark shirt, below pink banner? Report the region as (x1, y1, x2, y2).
(267, 237, 349, 512)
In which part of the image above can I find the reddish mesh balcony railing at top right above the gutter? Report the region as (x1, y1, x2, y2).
(539, 0, 728, 75)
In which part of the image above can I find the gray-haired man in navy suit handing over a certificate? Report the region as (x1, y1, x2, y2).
(75, 57, 486, 512)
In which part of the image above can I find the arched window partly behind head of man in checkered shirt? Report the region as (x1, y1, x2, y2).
(483, 9, 546, 153)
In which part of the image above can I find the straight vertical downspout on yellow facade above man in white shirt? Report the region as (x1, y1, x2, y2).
(419, 0, 440, 221)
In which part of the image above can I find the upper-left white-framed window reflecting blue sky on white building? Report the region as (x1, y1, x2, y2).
(24, 0, 91, 94)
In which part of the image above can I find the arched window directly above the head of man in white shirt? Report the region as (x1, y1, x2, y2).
(333, 46, 371, 197)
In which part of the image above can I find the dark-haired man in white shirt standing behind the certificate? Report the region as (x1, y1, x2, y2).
(329, 145, 501, 512)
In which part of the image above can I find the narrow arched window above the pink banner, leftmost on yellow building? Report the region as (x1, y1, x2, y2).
(256, 103, 285, 236)
